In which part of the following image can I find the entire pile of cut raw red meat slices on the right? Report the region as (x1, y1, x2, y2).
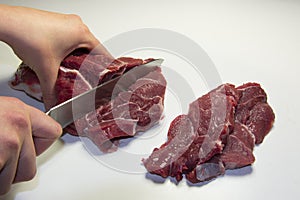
(143, 83, 275, 183)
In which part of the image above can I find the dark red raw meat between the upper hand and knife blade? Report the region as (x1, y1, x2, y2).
(55, 54, 144, 104)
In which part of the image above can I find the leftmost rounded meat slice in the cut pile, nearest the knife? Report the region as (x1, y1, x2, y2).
(143, 115, 196, 180)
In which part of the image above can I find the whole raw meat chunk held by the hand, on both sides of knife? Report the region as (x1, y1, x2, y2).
(10, 51, 166, 152)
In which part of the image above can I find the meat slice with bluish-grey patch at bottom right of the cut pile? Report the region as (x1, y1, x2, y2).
(186, 121, 255, 183)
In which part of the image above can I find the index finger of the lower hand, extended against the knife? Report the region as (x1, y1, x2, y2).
(28, 104, 62, 155)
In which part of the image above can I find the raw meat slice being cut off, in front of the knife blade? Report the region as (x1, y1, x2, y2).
(75, 68, 166, 152)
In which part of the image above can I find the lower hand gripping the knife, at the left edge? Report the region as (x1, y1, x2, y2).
(0, 97, 62, 195)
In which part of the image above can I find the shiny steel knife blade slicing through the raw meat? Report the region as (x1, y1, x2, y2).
(46, 59, 163, 128)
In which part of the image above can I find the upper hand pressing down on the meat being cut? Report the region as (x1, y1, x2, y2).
(0, 5, 112, 109)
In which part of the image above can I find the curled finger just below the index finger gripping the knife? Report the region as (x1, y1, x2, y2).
(13, 130, 36, 183)
